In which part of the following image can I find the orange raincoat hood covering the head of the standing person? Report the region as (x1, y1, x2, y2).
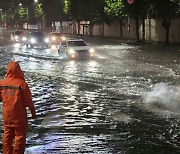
(6, 62, 25, 80)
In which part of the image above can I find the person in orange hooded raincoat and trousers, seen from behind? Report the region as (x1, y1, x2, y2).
(0, 62, 36, 154)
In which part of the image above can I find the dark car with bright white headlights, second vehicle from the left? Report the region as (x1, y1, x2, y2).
(26, 32, 49, 48)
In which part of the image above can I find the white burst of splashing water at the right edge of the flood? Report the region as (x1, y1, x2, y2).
(143, 83, 180, 112)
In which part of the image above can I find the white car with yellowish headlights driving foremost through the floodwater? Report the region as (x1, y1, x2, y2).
(58, 39, 95, 59)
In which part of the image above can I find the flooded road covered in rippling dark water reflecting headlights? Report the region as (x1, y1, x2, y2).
(0, 38, 180, 154)
